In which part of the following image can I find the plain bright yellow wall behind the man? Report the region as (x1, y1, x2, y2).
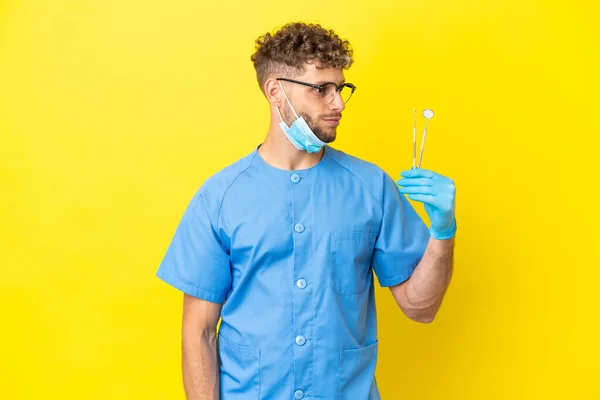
(0, 0, 600, 400)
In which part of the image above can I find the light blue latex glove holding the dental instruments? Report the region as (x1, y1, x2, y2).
(396, 168, 456, 240)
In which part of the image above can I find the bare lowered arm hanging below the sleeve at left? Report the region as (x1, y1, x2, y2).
(181, 294, 221, 400)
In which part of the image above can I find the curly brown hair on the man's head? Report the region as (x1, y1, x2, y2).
(250, 22, 354, 93)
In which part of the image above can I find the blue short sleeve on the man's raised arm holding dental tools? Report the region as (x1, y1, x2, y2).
(372, 174, 430, 287)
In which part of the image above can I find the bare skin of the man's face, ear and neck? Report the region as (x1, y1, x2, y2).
(258, 64, 348, 171)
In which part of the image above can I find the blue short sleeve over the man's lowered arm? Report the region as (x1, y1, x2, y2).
(156, 192, 231, 303)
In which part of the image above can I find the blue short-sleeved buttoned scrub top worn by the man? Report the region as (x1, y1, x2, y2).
(157, 146, 430, 400)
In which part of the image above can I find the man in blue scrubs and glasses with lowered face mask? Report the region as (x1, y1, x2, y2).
(157, 23, 456, 400)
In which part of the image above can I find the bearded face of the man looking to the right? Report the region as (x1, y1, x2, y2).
(279, 64, 348, 143)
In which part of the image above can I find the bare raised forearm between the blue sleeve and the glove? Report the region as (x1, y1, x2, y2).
(390, 237, 454, 323)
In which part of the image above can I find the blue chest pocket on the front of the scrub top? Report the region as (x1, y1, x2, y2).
(329, 232, 376, 294)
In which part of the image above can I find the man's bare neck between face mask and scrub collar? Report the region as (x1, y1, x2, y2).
(258, 122, 323, 171)
